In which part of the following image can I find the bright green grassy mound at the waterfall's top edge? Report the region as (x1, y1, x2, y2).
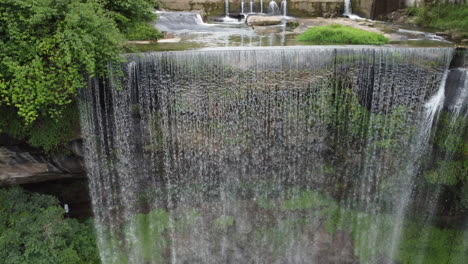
(297, 24, 389, 45)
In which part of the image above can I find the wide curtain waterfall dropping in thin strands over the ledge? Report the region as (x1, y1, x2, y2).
(80, 46, 467, 264)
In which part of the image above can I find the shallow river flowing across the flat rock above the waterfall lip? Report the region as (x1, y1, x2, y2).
(125, 11, 454, 52)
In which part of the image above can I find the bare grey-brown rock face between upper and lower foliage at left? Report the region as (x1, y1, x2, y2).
(0, 134, 86, 186)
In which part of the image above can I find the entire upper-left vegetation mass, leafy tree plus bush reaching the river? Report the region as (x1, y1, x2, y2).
(0, 0, 160, 149)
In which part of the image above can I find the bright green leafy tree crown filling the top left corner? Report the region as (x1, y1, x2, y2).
(0, 0, 123, 124)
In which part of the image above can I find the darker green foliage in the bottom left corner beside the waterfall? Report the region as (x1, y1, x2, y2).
(0, 187, 100, 264)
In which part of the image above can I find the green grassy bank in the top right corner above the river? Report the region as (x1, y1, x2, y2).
(414, 3, 468, 38)
